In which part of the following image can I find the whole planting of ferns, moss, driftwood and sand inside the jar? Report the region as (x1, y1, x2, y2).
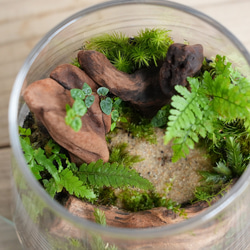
(19, 28, 250, 228)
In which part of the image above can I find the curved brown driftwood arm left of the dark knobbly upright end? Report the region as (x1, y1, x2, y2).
(78, 50, 165, 117)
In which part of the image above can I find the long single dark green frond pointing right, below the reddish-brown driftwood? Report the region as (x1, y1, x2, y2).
(75, 160, 153, 189)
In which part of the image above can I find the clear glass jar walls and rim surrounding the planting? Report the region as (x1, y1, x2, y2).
(9, 0, 250, 250)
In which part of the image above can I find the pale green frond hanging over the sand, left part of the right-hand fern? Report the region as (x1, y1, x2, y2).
(164, 78, 212, 162)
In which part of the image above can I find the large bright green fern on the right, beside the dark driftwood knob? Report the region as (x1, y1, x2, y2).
(165, 56, 250, 161)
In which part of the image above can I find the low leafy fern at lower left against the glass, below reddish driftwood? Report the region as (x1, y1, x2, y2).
(20, 132, 95, 200)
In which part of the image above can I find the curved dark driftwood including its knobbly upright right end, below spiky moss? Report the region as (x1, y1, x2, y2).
(78, 44, 204, 117)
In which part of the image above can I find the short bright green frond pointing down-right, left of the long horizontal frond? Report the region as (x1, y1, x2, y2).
(60, 168, 96, 199)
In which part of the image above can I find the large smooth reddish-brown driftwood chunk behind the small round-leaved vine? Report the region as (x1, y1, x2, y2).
(23, 78, 111, 163)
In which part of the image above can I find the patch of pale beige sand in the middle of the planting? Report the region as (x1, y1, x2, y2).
(109, 128, 212, 203)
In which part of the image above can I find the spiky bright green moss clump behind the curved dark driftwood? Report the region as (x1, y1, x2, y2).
(84, 28, 173, 73)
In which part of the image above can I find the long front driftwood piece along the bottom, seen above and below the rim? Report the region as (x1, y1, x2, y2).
(50, 180, 238, 250)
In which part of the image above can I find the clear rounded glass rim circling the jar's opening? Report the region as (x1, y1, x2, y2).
(8, 0, 250, 239)
